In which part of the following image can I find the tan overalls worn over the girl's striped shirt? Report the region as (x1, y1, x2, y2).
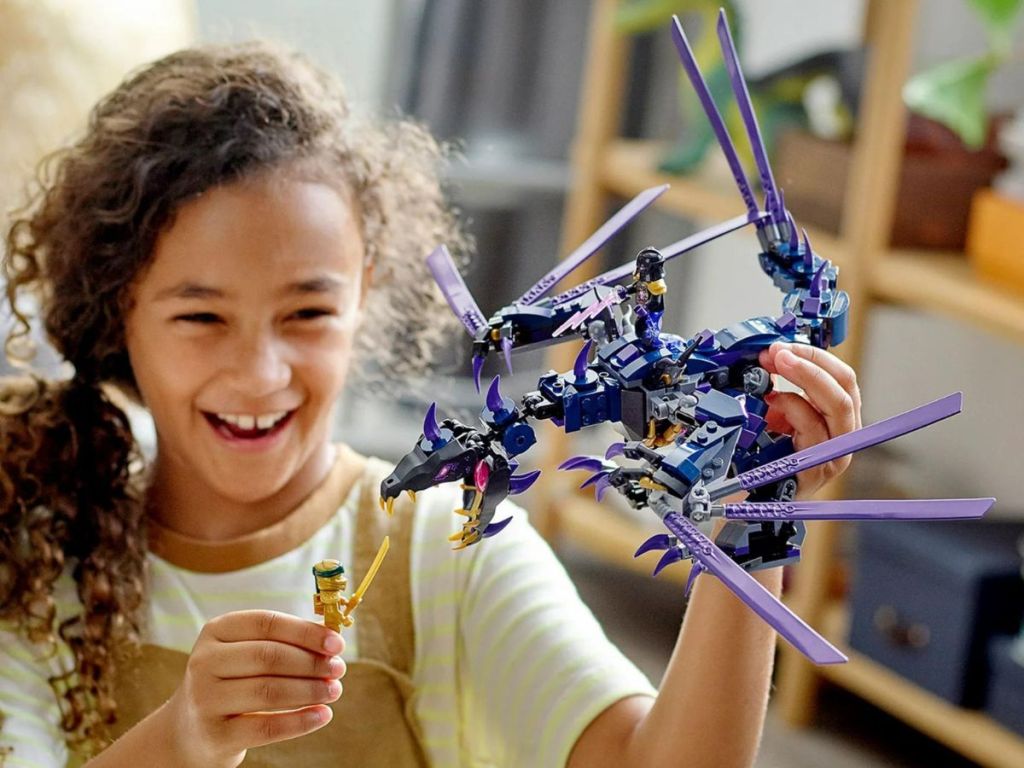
(99, 447, 428, 768)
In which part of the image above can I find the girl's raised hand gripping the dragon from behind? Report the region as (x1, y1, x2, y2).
(759, 343, 861, 499)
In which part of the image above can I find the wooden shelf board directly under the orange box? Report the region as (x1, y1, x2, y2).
(869, 251, 1024, 342)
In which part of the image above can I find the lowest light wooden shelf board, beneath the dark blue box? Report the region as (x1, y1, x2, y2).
(818, 604, 1024, 768)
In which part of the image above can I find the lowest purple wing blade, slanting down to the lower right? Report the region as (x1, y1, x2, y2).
(665, 512, 847, 664)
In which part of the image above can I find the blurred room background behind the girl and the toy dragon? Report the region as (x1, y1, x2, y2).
(0, 0, 1024, 767)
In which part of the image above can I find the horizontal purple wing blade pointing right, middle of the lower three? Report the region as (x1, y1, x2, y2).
(721, 499, 995, 520)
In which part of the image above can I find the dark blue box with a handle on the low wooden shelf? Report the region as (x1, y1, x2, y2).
(850, 521, 1024, 708)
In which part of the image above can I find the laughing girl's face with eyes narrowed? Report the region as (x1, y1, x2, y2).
(126, 174, 367, 514)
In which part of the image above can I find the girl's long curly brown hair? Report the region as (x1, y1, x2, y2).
(0, 43, 469, 754)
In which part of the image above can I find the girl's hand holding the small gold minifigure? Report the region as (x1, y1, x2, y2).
(166, 610, 345, 768)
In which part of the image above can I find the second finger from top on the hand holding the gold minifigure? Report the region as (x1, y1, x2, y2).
(209, 640, 345, 679)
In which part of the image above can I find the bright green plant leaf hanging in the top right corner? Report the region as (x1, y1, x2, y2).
(903, 0, 1024, 150)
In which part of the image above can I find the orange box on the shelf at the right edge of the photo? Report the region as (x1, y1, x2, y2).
(967, 187, 1024, 293)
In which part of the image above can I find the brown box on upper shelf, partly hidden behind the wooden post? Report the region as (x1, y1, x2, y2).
(773, 116, 1006, 251)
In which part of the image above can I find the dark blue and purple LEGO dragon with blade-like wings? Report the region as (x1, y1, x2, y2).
(380, 12, 994, 664)
